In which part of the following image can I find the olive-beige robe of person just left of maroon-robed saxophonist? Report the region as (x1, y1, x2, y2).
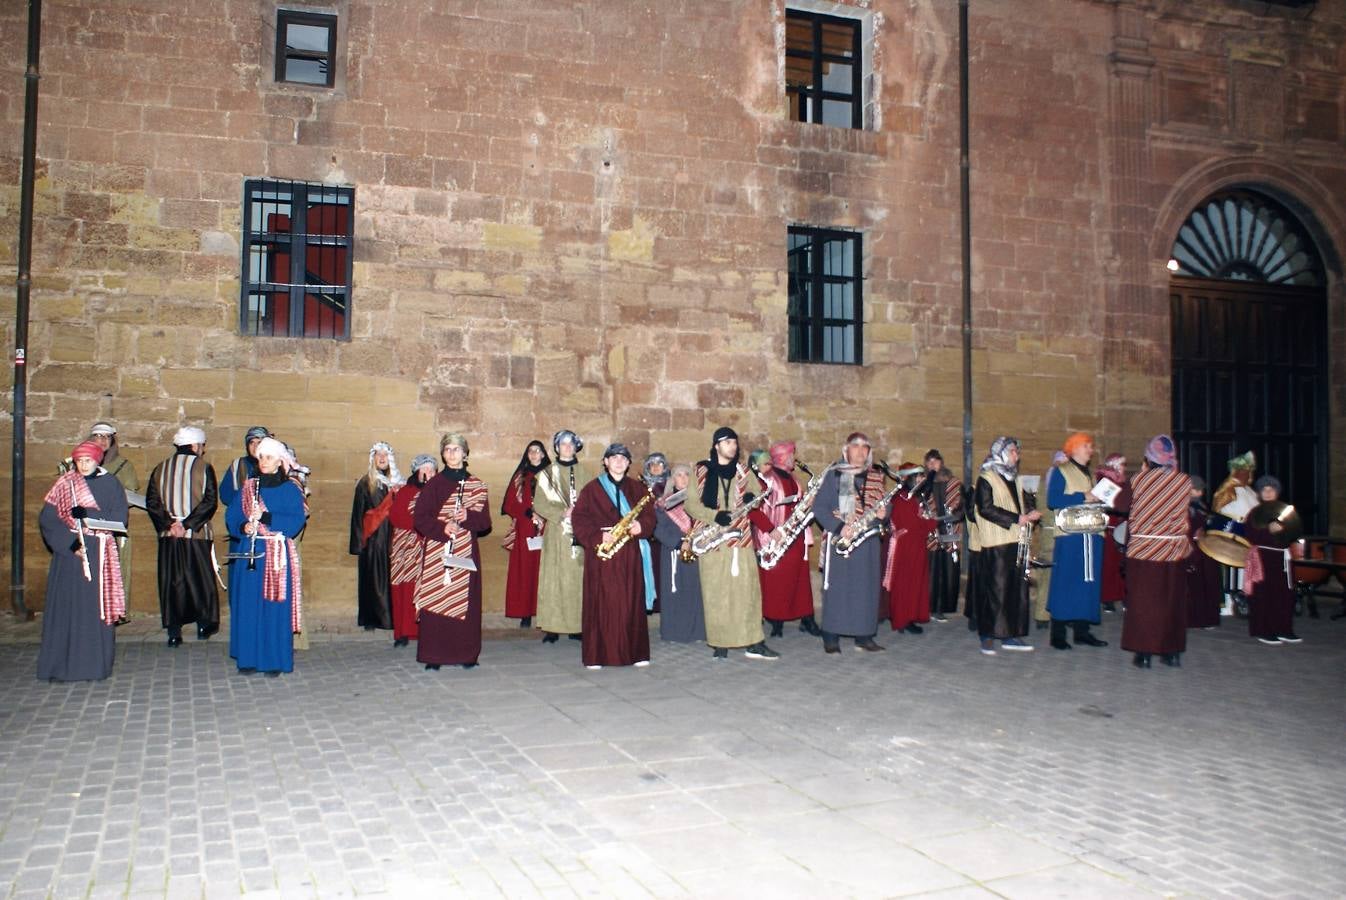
(533, 461, 594, 635)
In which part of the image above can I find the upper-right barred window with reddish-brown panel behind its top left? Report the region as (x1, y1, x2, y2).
(785, 9, 864, 128)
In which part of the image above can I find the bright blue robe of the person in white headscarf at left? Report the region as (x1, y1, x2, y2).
(225, 480, 304, 671)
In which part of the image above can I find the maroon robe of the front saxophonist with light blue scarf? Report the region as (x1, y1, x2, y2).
(571, 472, 654, 666)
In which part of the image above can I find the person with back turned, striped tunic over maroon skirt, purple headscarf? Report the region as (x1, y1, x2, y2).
(1113, 435, 1191, 669)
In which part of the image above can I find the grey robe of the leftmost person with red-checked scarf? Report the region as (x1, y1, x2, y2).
(38, 474, 127, 681)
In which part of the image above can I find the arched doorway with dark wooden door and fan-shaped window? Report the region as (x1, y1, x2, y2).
(1168, 188, 1329, 533)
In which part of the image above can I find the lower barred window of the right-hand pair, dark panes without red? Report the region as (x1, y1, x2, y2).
(787, 225, 864, 366)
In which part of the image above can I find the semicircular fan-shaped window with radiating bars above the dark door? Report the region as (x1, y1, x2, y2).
(1168, 191, 1323, 288)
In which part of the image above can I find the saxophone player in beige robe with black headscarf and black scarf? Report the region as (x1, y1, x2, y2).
(682, 426, 781, 659)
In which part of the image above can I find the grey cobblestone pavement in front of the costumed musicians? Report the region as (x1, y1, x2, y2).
(0, 607, 1346, 899)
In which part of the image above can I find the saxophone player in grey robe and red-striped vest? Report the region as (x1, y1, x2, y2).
(813, 432, 888, 654)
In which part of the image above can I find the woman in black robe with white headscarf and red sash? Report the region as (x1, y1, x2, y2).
(350, 441, 402, 631)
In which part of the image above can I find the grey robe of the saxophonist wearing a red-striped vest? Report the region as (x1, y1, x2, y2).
(813, 471, 883, 638)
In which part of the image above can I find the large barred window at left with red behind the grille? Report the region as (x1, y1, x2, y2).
(238, 179, 355, 339)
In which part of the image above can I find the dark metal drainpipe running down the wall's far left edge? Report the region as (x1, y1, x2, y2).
(9, 0, 42, 620)
